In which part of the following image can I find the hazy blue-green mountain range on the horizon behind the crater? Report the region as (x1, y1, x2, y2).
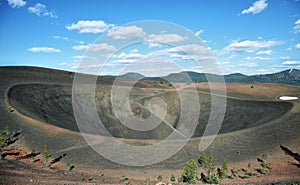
(121, 69, 300, 86)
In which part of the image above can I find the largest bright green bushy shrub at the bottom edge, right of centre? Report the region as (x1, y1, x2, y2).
(182, 159, 198, 183)
